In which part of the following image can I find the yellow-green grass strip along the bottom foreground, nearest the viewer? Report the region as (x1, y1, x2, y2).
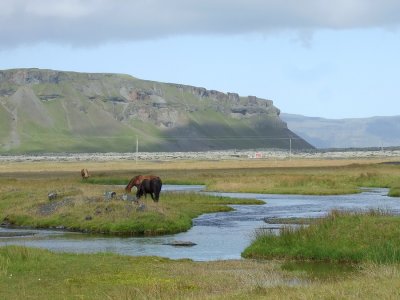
(0, 246, 400, 299)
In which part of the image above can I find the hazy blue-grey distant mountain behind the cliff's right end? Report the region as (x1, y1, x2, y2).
(281, 114, 400, 148)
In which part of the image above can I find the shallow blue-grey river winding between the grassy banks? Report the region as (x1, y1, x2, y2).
(0, 185, 400, 261)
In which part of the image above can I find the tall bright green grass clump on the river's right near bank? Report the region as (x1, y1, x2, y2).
(242, 211, 400, 263)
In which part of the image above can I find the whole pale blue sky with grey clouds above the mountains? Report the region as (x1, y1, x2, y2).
(0, 0, 400, 119)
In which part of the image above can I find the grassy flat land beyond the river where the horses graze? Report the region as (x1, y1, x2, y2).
(0, 159, 400, 235)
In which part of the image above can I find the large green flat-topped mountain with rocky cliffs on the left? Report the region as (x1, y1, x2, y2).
(0, 69, 313, 153)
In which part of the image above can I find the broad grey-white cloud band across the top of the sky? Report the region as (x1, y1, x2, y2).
(0, 0, 400, 48)
